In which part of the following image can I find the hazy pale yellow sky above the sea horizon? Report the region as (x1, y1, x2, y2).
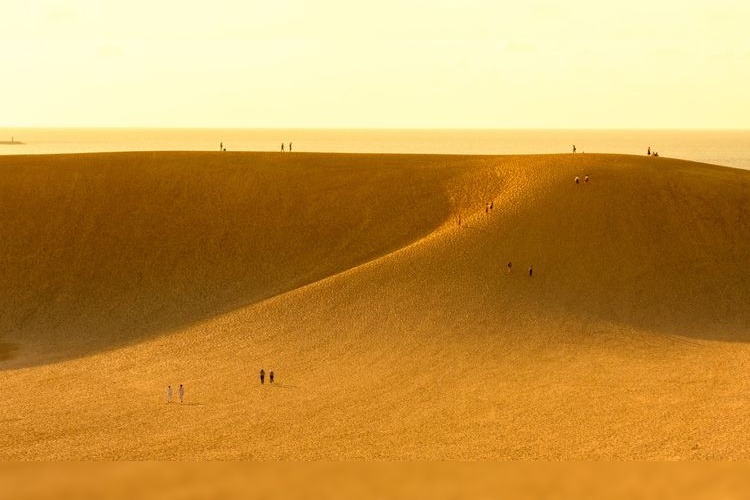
(0, 0, 750, 128)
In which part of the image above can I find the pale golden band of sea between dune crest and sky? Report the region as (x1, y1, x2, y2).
(0, 128, 750, 170)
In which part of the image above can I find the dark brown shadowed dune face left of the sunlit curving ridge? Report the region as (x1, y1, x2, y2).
(0, 153, 452, 368)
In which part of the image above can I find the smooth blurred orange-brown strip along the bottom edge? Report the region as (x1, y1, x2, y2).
(0, 461, 748, 500)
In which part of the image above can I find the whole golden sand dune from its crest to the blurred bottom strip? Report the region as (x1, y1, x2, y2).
(0, 152, 750, 460)
